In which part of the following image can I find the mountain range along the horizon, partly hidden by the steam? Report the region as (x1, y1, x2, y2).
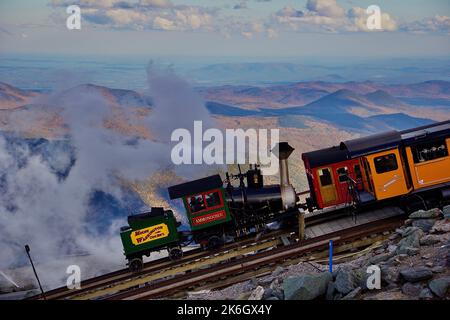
(0, 81, 450, 137)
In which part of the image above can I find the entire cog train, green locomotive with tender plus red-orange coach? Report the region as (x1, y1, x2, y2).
(120, 121, 450, 272)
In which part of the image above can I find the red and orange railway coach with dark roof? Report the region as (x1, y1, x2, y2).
(302, 121, 450, 211)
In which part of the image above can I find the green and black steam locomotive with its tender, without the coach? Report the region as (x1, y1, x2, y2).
(120, 142, 298, 272)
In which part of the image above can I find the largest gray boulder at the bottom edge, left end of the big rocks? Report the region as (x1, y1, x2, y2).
(283, 272, 332, 300)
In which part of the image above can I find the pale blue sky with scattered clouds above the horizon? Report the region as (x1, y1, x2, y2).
(0, 0, 450, 58)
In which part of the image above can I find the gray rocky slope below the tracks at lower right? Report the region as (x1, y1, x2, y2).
(188, 206, 450, 300)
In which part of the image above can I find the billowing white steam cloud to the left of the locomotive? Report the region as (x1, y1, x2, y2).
(0, 64, 214, 288)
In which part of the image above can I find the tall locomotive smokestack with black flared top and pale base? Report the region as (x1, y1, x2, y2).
(272, 142, 297, 209)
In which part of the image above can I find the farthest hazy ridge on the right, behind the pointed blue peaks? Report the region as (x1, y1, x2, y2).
(200, 81, 450, 109)
